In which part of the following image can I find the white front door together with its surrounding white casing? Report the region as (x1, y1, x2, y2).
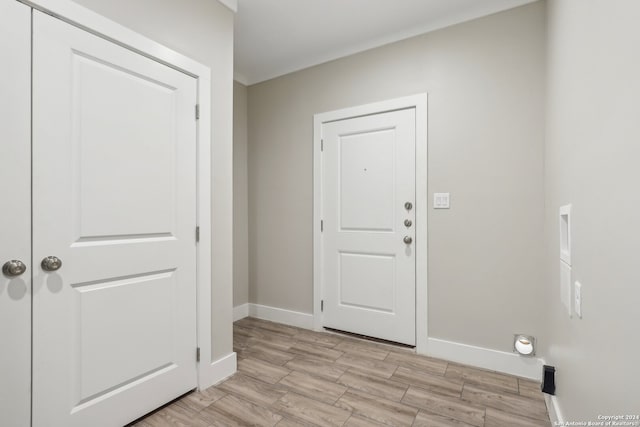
(314, 94, 427, 353)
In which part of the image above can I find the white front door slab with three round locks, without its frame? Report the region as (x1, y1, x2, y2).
(321, 108, 416, 345)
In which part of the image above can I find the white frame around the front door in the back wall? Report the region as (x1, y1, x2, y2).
(313, 93, 428, 354)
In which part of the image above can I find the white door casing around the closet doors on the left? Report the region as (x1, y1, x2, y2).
(16, 0, 218, 389)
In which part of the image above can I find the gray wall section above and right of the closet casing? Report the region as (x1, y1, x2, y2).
(75, 0, 233, 359)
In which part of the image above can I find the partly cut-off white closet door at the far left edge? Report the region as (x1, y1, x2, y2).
(0, 0, 32, 427)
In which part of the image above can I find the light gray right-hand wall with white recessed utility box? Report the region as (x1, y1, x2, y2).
(543, 0, 640, 421)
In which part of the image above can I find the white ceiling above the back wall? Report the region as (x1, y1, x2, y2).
(234, 0, 535, 85)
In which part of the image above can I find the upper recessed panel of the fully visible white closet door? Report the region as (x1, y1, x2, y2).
(71, 52, 178, 239)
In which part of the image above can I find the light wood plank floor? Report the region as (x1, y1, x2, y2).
(131, 318, 550, 427)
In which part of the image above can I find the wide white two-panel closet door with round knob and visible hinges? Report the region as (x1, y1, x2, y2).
(33, 12, 196, 427)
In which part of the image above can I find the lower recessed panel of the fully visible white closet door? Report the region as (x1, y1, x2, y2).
(72, 271, 178, 404)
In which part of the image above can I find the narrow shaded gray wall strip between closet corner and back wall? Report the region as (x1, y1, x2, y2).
(233, 82, 249, 307)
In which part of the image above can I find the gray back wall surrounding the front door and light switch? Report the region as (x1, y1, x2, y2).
(248, 2, 545, 351)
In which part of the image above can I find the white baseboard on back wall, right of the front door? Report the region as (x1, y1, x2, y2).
(426, 338, 544, 381)
